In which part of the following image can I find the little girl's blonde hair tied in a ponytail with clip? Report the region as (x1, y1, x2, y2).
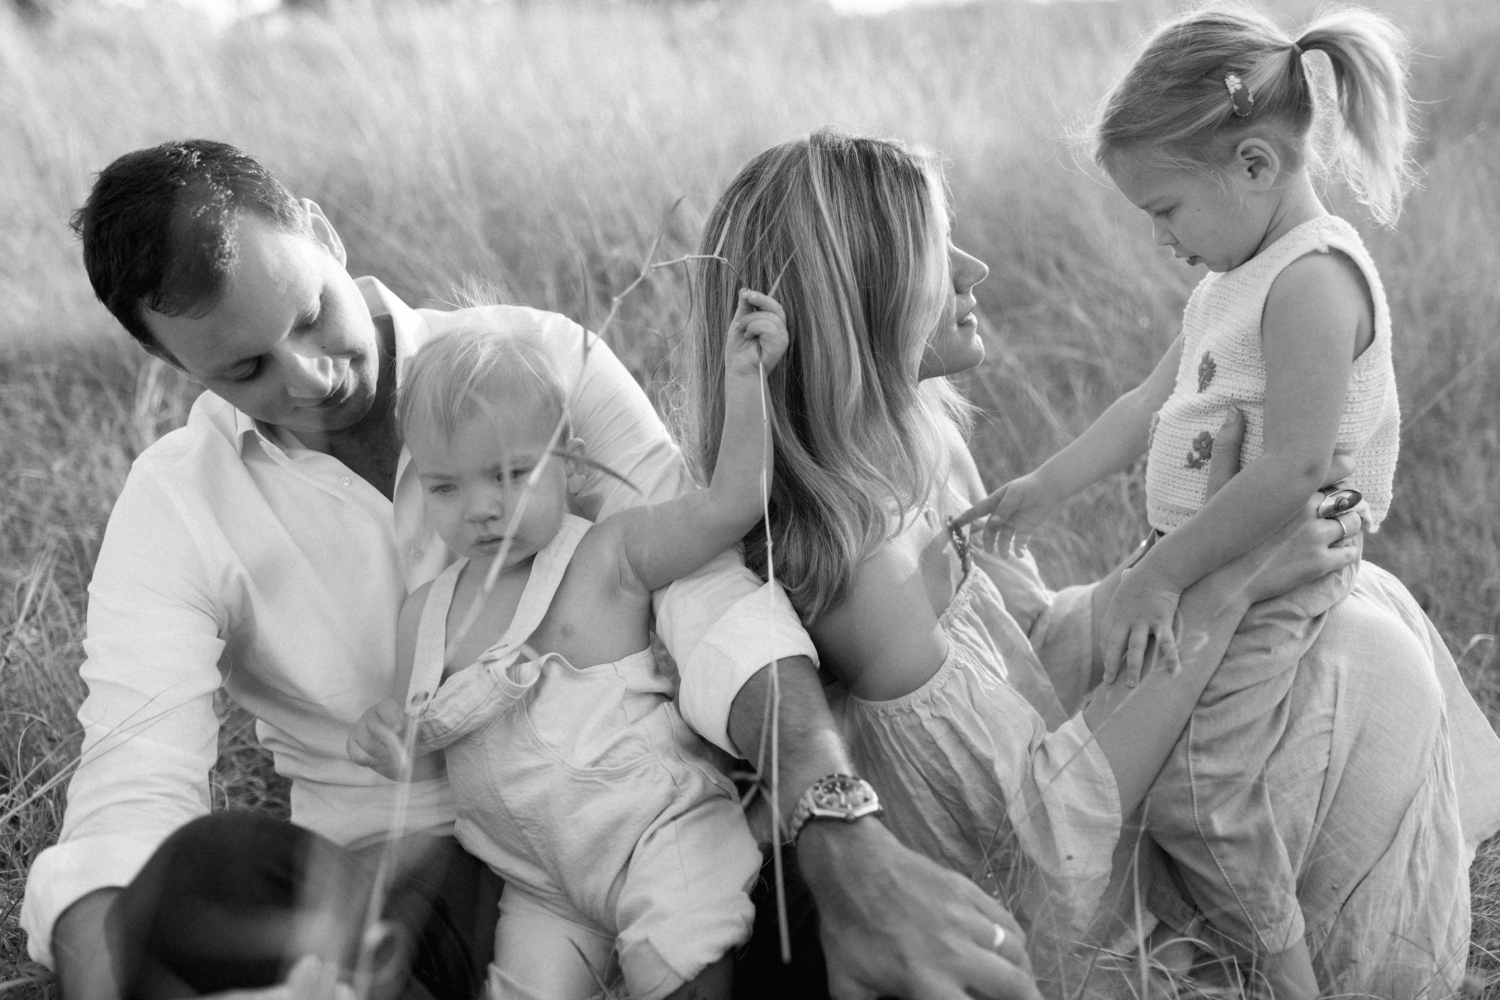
(1094, 3, 1413, 225)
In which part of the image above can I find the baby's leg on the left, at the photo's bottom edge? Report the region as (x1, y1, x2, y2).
(488, 883, 617, 1000)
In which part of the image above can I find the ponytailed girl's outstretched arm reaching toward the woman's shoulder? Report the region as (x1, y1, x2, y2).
(957, 336, 1182, 547)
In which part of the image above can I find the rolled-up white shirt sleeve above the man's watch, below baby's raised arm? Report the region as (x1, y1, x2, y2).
(657, 552, 818, 757)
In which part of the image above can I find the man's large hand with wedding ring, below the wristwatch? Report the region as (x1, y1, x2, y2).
(798, 819, 1041, 1000)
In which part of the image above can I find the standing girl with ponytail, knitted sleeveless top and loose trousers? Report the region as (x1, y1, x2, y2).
(962, 7, 1410, 997)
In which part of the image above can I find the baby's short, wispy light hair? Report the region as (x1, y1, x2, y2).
(396, 321, 567, 441)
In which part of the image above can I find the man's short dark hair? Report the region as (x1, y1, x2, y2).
(72, 139, 312, 352)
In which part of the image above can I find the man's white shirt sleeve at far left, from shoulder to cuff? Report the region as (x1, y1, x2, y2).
(21, 468, 224, 966)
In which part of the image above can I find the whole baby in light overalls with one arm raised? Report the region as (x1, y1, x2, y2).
(350, 302, 786, 1000)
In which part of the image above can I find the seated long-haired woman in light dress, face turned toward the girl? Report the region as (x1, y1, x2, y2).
(689, 130, 1500, 996)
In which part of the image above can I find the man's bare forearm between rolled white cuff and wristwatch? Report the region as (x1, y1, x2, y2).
(729, 657, 852, 835)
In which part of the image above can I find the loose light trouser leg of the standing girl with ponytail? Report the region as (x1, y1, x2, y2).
(1146, 567, 1358, 997)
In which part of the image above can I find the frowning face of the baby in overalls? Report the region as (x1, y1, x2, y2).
(407, 399, 567, 568)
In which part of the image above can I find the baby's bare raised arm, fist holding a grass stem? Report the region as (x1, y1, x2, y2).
(606, 289, 788, 591)
